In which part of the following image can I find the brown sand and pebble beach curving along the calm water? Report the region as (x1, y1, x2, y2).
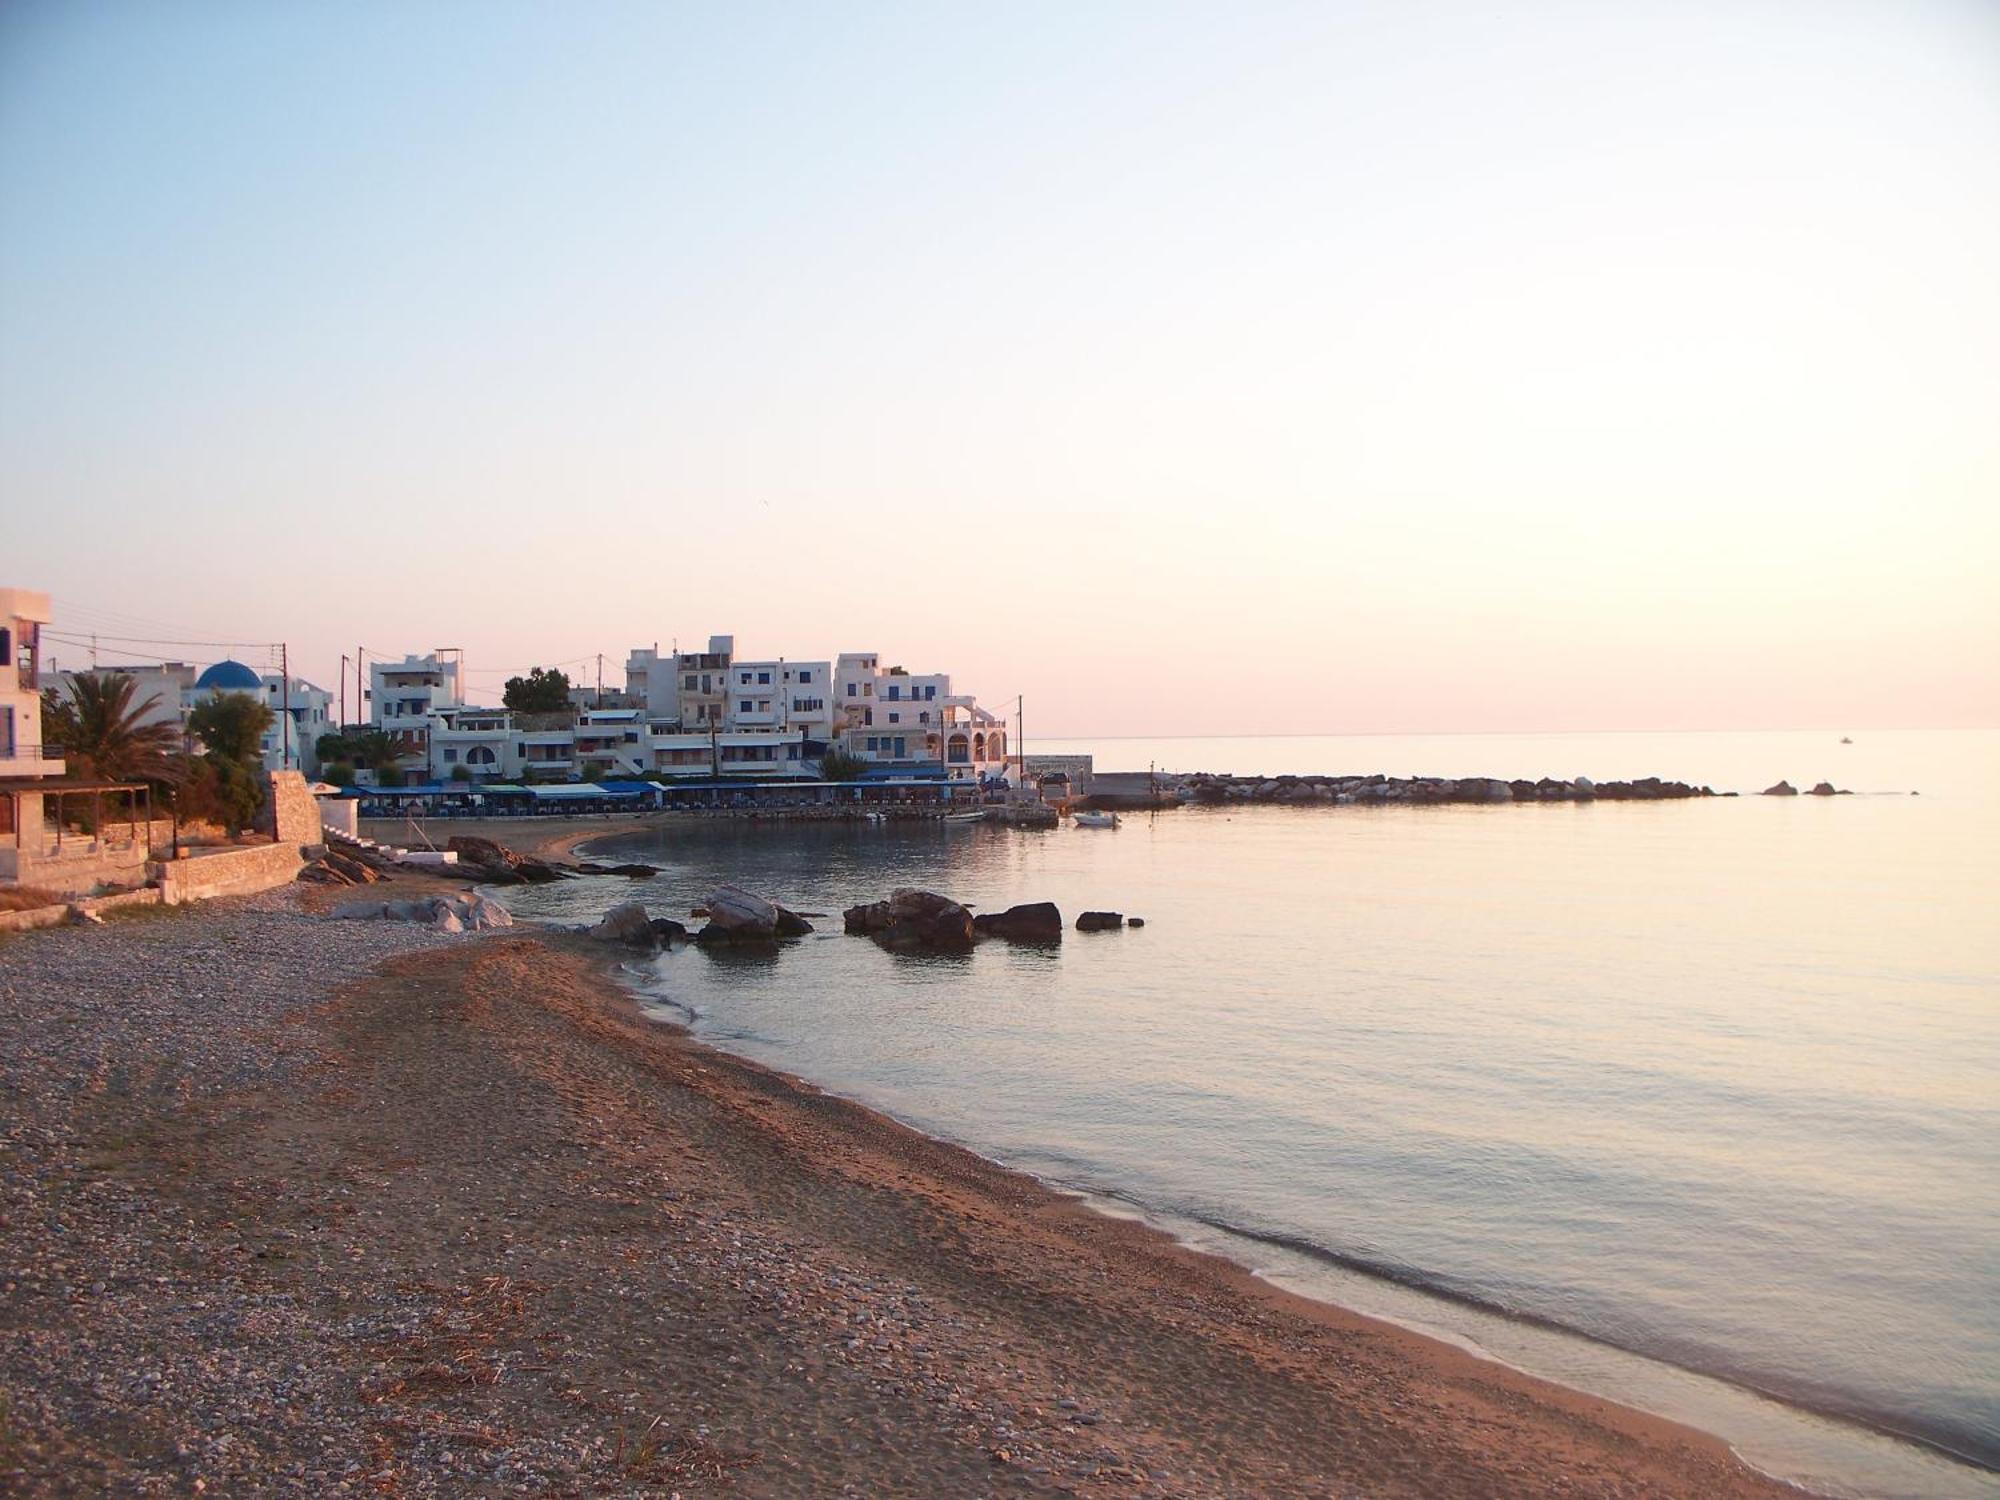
(0, 876, 1794, 1496)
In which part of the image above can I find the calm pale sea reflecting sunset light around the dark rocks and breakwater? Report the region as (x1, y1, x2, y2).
(496, 732, 2000, 1496)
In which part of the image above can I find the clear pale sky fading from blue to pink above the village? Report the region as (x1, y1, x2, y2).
(0, 0, 2000, 748)
